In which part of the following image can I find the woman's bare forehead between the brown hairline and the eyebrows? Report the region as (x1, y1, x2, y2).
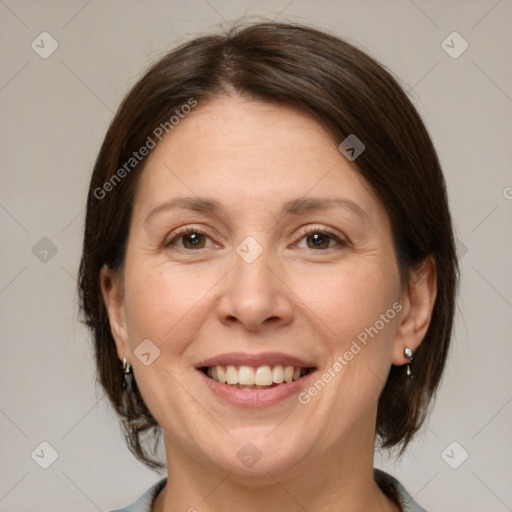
(135, 98, 382, 224)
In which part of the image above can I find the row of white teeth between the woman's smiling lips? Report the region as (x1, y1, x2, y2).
(199, 364, 314, 389)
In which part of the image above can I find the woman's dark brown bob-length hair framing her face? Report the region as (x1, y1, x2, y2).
(78, 22, 459, 469)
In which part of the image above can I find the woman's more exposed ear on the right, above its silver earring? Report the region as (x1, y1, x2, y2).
(392, 257, 437, 366)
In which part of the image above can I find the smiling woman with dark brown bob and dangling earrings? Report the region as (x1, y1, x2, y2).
(79, 23, 457, 512)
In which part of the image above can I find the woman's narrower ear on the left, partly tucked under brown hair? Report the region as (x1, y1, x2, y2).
(100, 264, 129, 361)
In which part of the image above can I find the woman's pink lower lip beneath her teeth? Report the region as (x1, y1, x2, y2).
(198, 370, 315, 408)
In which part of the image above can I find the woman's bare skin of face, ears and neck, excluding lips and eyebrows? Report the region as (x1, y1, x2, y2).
(101, 97, 435, 512)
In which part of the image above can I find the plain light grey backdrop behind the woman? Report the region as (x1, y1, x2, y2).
(0, 0, 512, 512)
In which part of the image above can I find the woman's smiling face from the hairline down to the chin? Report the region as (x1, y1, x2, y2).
(104, 98, 416, 476)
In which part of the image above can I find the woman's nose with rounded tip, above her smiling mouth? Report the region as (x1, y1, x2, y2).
(217, 242, 294, 333)
